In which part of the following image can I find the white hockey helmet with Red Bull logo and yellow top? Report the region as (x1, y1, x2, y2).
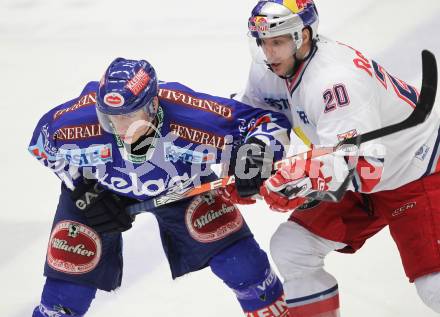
(248, 0, 319, 50)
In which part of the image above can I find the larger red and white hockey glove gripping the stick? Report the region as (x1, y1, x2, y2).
(260, 159, 332, 212)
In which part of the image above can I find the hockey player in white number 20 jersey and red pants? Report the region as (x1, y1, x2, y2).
(227, 0, 440, 317)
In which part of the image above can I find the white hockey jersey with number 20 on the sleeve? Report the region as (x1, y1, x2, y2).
(241, 38, 440, 192)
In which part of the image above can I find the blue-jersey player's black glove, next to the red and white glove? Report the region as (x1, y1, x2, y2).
(231, 137, 273, 198)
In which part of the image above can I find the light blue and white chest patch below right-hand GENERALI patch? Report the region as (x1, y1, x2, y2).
(163, 142, 215, 164)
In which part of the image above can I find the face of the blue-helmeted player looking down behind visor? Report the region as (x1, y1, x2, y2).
(111, 97, 158, 144)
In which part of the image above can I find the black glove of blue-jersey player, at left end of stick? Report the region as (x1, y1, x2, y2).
(71, 180, 138, 233)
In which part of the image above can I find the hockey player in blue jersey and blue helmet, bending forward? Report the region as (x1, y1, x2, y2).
(29, 58, 290, 317)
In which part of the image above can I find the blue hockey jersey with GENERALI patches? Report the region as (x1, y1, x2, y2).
(29, 82, 290, 200)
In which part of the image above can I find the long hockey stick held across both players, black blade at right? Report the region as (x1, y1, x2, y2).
(126, 50, 437, 215)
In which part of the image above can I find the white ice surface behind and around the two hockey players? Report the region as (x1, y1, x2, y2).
(0, 0, 440, 317)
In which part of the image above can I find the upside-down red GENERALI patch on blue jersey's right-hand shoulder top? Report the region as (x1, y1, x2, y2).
(158, 89, 232, 119)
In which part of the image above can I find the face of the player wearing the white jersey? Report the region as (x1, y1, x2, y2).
(261, 35, 295, 76)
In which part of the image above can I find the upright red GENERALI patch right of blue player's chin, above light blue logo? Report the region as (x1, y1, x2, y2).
(170, 123, 225, 149)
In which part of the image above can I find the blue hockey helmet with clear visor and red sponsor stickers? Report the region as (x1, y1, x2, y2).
(96, 57, 158, 137)
